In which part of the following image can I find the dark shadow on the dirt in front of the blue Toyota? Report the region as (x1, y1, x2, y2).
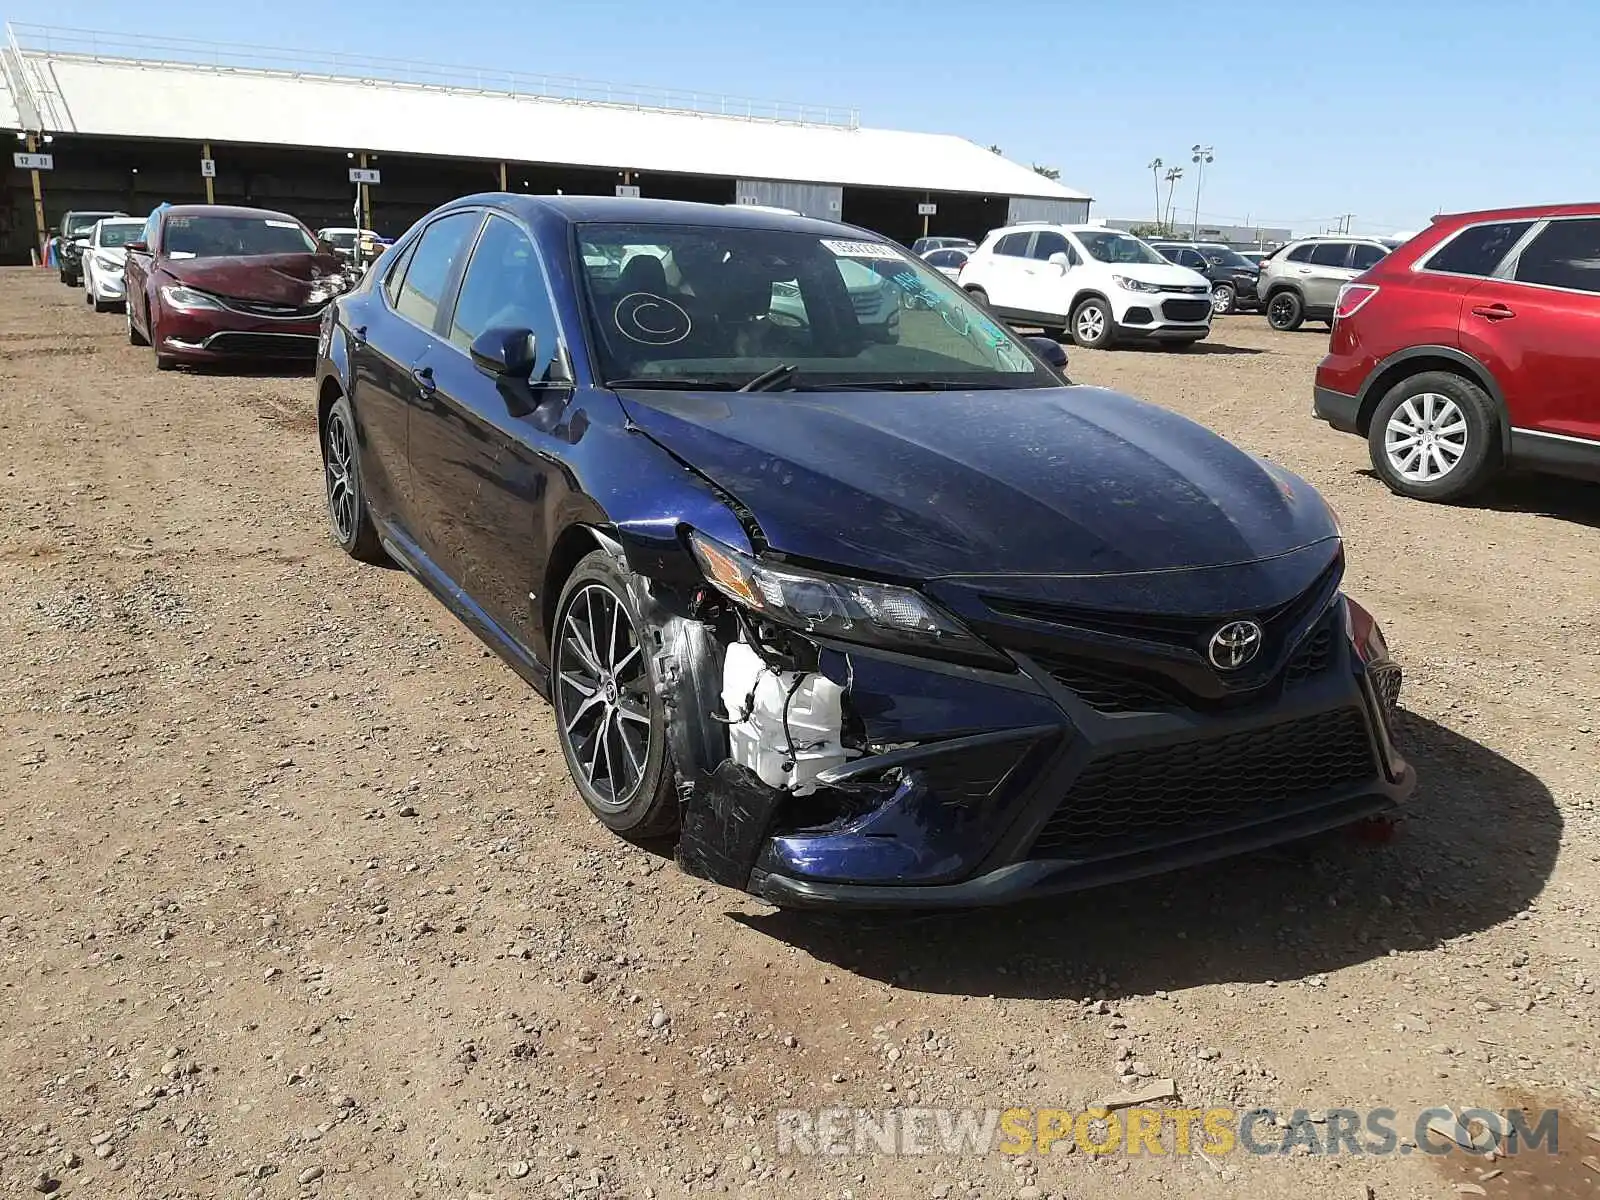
(734, 714, 1562, 998)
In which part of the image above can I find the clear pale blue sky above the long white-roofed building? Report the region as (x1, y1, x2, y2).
(21, 0, 1600, 232)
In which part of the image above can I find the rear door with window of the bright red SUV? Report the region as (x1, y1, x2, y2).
(1461, 216, 1600, 451)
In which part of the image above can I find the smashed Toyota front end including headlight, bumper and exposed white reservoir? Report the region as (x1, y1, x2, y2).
(617, 533, 1414, 907)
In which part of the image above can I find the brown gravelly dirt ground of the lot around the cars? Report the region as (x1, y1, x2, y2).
(0, 270, 1600, 1200)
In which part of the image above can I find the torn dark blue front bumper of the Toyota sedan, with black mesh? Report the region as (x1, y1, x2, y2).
(694, 573, 1416, 909)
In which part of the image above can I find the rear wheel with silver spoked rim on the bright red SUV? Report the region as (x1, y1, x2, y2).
(1366, 371, 1499, 502)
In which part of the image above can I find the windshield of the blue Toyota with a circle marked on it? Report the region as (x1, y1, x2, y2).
(578, 224, 1061, 389)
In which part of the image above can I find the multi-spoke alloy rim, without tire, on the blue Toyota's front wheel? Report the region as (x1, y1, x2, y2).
(555, 584, 653, 811)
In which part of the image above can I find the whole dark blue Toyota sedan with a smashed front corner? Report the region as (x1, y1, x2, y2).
(317, 194, 1414, 907)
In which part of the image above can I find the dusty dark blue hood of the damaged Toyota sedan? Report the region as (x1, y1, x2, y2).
(619, 387, 1338, 579)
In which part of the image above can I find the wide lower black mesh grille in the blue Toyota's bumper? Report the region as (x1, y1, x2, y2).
(1032, 709, 1378, 858)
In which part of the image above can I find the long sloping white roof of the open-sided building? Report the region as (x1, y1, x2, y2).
(22, 50, 1090, 200)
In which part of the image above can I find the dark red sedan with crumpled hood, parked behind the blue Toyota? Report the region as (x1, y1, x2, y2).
(126, 205, 349, 370)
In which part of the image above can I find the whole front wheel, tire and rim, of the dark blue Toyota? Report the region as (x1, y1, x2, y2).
(550, 550, 678, 838)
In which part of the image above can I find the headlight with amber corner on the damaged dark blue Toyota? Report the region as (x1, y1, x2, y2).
(690, 533, 1005, 662)
